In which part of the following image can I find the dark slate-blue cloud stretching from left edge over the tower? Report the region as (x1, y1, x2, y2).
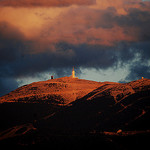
(0, 22, 116, 78)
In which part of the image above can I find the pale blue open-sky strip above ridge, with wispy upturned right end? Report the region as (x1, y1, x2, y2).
(16, 50, 146, 87)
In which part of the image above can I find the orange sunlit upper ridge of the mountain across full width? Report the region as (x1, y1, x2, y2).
(0, 77, 150, 105)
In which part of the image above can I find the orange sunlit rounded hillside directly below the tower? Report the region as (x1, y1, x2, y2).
(0, 77, 101, 104)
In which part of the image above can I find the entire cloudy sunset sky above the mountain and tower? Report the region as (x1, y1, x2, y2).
(0, 0, 150, 96)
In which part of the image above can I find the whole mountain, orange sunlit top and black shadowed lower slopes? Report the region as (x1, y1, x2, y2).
(0, 77, 150, 149)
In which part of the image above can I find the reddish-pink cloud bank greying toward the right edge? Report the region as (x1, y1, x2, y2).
(40, 7, 150, 46)
